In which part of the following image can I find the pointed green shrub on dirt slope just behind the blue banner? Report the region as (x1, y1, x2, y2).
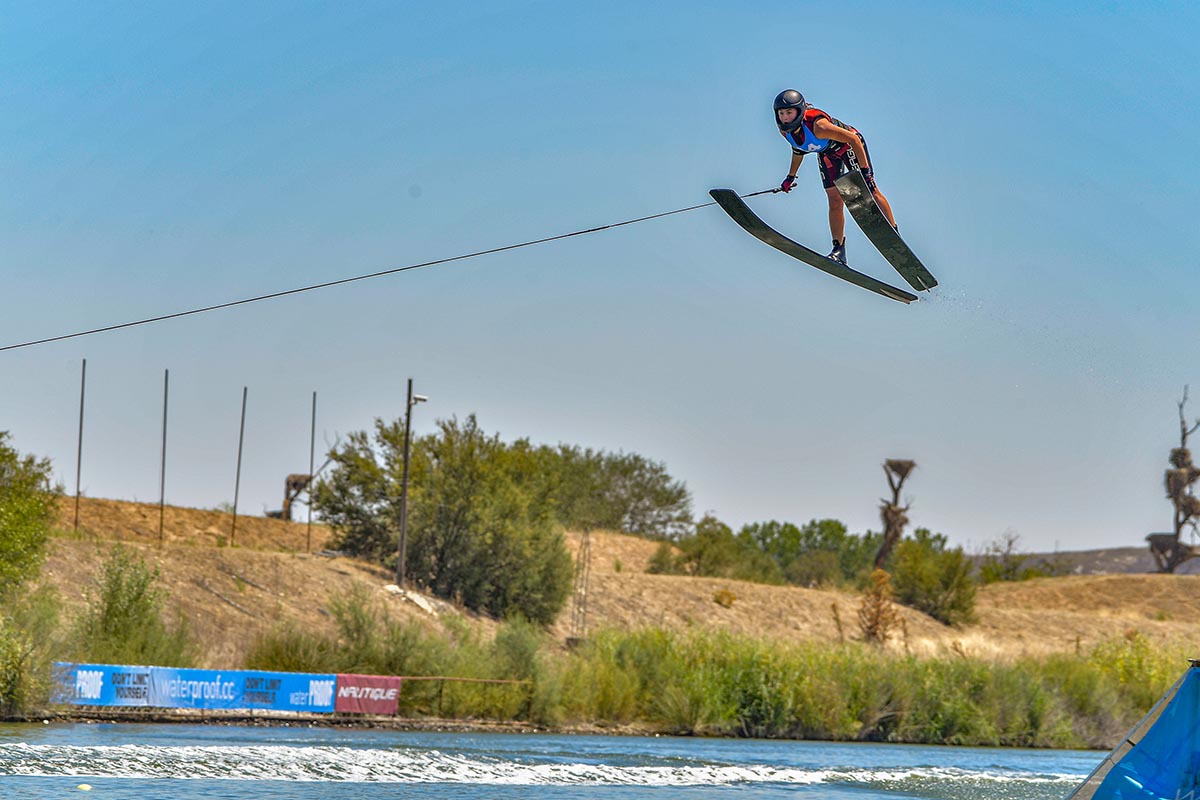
(73, 546, 193, 667)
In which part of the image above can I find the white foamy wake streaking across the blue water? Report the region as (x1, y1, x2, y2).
(0, 744, 1082, 798)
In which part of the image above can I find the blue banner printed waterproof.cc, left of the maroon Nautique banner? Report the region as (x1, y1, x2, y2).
(54, 663, 337, 714)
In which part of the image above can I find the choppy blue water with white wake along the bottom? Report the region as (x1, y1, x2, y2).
(0, 724, 1102, 800)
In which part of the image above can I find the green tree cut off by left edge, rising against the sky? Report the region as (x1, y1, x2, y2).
(0, 431, 59, 595)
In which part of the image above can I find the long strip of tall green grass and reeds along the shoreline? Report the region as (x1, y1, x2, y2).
(248, 594, 1187, 747)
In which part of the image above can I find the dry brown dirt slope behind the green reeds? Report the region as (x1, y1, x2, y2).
(43, 498, 1200, 668)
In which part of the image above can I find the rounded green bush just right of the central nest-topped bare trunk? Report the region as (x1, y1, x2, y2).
(892, 528, 976, 625)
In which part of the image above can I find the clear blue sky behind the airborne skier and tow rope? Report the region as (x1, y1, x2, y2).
(0, 0, 1200, 549)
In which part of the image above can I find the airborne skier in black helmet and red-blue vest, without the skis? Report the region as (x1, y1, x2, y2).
(775, 89, 896, 264)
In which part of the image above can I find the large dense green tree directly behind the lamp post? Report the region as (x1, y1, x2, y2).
(313, 415, 572, 624)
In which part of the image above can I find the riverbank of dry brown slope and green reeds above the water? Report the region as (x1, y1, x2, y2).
(14, 501, 1200, 747)
